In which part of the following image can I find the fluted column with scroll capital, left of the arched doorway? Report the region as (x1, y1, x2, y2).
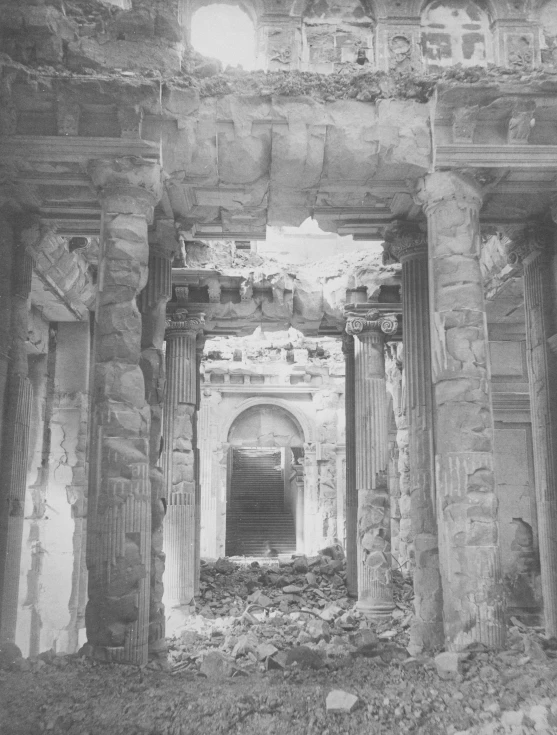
(164, 309, 204, 628)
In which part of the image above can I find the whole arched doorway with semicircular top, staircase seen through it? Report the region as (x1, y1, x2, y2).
(225, 404, 304, 556)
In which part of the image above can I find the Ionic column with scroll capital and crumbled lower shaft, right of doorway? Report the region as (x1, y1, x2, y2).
(346, 311, 397, 619)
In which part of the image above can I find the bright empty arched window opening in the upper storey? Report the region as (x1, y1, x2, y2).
(191, 4, 256, 71)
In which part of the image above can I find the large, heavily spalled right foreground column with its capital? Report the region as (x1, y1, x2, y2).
(417, 172, 505, 650)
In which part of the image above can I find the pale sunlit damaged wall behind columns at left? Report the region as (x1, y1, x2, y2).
(16, 322, 89, 655)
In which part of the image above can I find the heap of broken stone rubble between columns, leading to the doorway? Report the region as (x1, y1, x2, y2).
(165, 547, 413, 678)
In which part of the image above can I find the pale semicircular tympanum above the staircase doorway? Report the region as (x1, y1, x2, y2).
(228, 404, 304, 448)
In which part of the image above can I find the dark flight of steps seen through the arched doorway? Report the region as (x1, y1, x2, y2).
(226, 448, 296, 556)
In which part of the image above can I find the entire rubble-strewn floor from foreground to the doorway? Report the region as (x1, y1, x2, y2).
(0, 550, 557, 735)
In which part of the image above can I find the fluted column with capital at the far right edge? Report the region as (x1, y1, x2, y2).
(506, 223, 557, 637)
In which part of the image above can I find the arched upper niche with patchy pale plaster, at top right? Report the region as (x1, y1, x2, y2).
(421, 0, 493, 70)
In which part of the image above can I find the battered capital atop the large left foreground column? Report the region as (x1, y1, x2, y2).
(87, 156, 162, 221)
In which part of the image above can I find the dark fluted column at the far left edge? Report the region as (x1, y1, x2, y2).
(0, 228, 33, 645)
